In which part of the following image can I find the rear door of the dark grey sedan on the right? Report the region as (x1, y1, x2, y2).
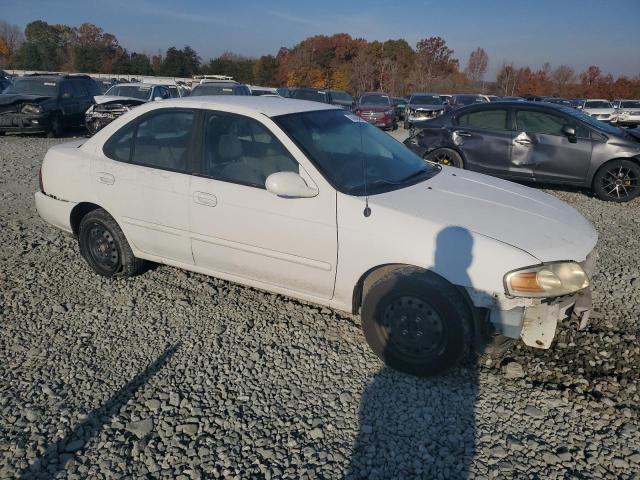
(452, 108, 533, 180)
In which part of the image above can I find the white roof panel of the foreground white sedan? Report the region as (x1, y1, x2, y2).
(154, 95, 341, 117)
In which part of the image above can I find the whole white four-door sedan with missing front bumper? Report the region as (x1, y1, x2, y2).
(35, 96, 597, 375)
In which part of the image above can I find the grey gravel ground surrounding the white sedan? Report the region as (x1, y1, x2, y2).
(0, 131, 640, 479)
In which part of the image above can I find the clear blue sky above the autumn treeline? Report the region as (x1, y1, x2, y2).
(0, 0, 640, 79)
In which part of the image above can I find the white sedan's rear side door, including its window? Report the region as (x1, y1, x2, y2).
(92, 108, 196, 264)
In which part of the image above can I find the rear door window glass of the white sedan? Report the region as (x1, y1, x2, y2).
(104, 109, 195, 173)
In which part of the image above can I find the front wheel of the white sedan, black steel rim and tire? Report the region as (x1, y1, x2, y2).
(361, 267, 472, 377)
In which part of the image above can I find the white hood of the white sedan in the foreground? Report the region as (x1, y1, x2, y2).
(369, 167, 598, 262)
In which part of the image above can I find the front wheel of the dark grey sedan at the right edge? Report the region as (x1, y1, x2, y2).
(593, 160, 640, 203)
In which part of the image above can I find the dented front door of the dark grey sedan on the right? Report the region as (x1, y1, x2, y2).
(512, 107, 592, 184)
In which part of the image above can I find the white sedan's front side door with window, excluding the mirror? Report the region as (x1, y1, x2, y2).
(190, 112, 337, 299)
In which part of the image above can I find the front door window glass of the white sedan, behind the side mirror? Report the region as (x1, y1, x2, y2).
(202, 112, 299, 188)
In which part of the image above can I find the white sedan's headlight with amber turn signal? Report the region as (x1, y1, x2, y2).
(504, 262, 589, 297)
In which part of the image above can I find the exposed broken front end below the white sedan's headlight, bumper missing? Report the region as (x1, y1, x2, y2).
(466, 250, 597, 349)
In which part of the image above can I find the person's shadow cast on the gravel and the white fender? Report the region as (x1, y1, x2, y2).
(346, 227, 478, 480)
